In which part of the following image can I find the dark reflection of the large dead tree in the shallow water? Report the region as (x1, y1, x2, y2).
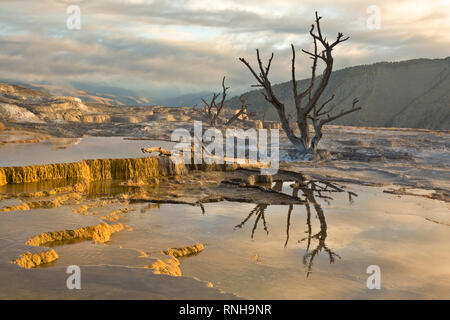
(235, 180, 357, 277)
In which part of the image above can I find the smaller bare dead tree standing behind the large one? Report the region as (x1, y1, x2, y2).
(202, 77, 250, 128)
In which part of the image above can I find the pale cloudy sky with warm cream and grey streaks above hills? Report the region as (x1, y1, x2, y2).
(0, 0, 450, 99)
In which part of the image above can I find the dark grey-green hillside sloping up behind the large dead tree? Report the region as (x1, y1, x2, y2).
(227, 57, 450, 130)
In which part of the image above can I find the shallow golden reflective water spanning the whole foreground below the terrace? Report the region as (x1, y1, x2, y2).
(0, 179, 450, 299)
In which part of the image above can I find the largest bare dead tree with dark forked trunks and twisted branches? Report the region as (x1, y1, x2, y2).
(239, 12, 361, 154)
